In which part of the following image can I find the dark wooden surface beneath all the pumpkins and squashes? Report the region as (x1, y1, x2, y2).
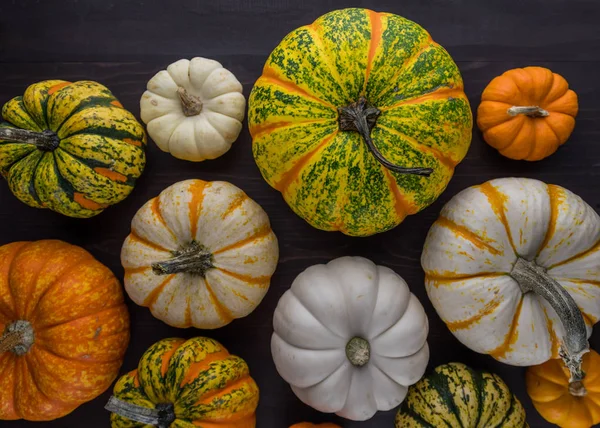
(0, 0, 600, 428)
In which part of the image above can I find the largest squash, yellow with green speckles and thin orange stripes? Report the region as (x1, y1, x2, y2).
(248, 9, 473, 236)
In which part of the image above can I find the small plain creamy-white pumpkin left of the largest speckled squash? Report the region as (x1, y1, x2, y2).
(140, 58, 246, 162)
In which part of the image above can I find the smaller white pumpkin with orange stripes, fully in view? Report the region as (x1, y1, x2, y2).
(121, 180, 279, 329)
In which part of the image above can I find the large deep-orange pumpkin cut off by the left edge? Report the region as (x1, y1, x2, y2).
(0, 241, 129, 421)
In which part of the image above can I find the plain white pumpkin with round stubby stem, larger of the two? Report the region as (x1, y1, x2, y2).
(271, 257, 429, 420)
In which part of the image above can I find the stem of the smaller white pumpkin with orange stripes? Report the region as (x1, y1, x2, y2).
(152, 241, 214, 277)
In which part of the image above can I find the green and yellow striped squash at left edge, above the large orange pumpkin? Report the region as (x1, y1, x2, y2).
(0, 80, 146, 218)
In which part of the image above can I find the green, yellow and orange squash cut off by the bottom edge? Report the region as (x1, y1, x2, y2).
(106, 337, 259, 428)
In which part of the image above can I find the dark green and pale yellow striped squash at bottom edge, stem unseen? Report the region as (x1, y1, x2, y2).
(396, 363, 528, 428)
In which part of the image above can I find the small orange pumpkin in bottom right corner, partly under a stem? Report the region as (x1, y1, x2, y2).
(525, 351, 600, 428)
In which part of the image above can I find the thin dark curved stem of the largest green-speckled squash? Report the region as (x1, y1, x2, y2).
(338, 97, 433, 177)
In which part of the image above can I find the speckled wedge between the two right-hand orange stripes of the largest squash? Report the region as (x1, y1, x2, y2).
(377, 95, 473, 164)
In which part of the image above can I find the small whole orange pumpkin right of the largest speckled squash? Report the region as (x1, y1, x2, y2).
(477, 67, 578, 161)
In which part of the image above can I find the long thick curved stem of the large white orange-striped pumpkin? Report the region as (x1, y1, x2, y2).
(510, 257, 590, 382)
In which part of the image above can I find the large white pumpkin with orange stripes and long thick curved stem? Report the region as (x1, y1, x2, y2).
(421, 178, 600, 381)
